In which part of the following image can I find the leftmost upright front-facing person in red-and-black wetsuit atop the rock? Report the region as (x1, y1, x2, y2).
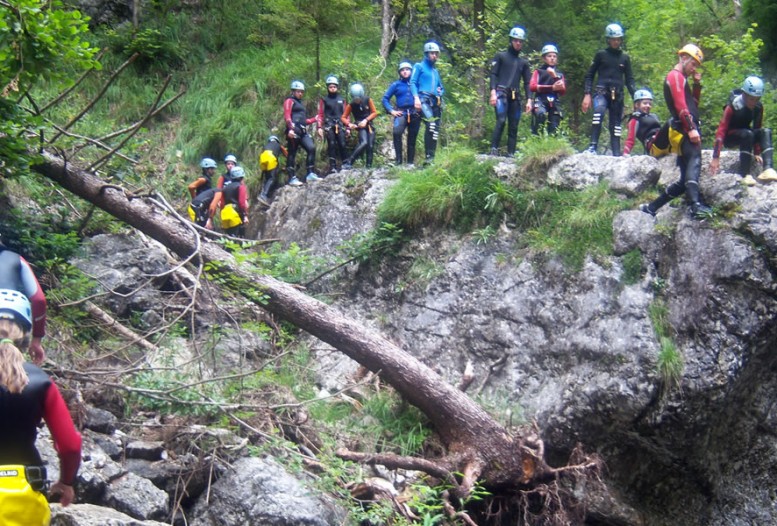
(283, 80, 319, 186)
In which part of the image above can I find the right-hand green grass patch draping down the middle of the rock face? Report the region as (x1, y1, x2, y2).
(513, 182, 631, 271)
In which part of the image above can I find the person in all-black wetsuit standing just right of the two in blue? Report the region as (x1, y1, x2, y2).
(489, 27, 532, 155)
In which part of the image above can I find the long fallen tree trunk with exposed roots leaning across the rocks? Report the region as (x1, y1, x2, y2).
(34, 153, 588, 492)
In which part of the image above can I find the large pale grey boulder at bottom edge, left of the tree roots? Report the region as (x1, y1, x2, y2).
(191, 457, 344, 526)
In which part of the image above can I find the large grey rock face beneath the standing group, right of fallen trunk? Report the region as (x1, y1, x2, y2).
(261, 152, 777, 525)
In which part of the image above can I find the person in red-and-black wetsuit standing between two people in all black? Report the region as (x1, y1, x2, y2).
(529, 44, 567, 135)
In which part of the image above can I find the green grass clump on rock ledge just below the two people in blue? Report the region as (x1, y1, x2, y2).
(378, 150, 506, 230)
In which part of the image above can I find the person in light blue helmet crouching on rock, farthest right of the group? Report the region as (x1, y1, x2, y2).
(710, 76, 777, 186)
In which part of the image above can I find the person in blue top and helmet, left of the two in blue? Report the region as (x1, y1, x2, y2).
(383, 62, 421, 166)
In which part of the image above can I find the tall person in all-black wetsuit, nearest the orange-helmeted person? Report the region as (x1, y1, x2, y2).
(582, 24, 636, 156)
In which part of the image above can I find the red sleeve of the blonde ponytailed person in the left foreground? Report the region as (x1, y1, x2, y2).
(43, 382, 81, 486)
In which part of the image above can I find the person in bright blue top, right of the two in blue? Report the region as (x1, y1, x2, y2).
(410, 42, 445, 164)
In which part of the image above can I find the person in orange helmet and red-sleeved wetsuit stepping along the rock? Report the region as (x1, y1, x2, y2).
(640, 44, 712, 219)
